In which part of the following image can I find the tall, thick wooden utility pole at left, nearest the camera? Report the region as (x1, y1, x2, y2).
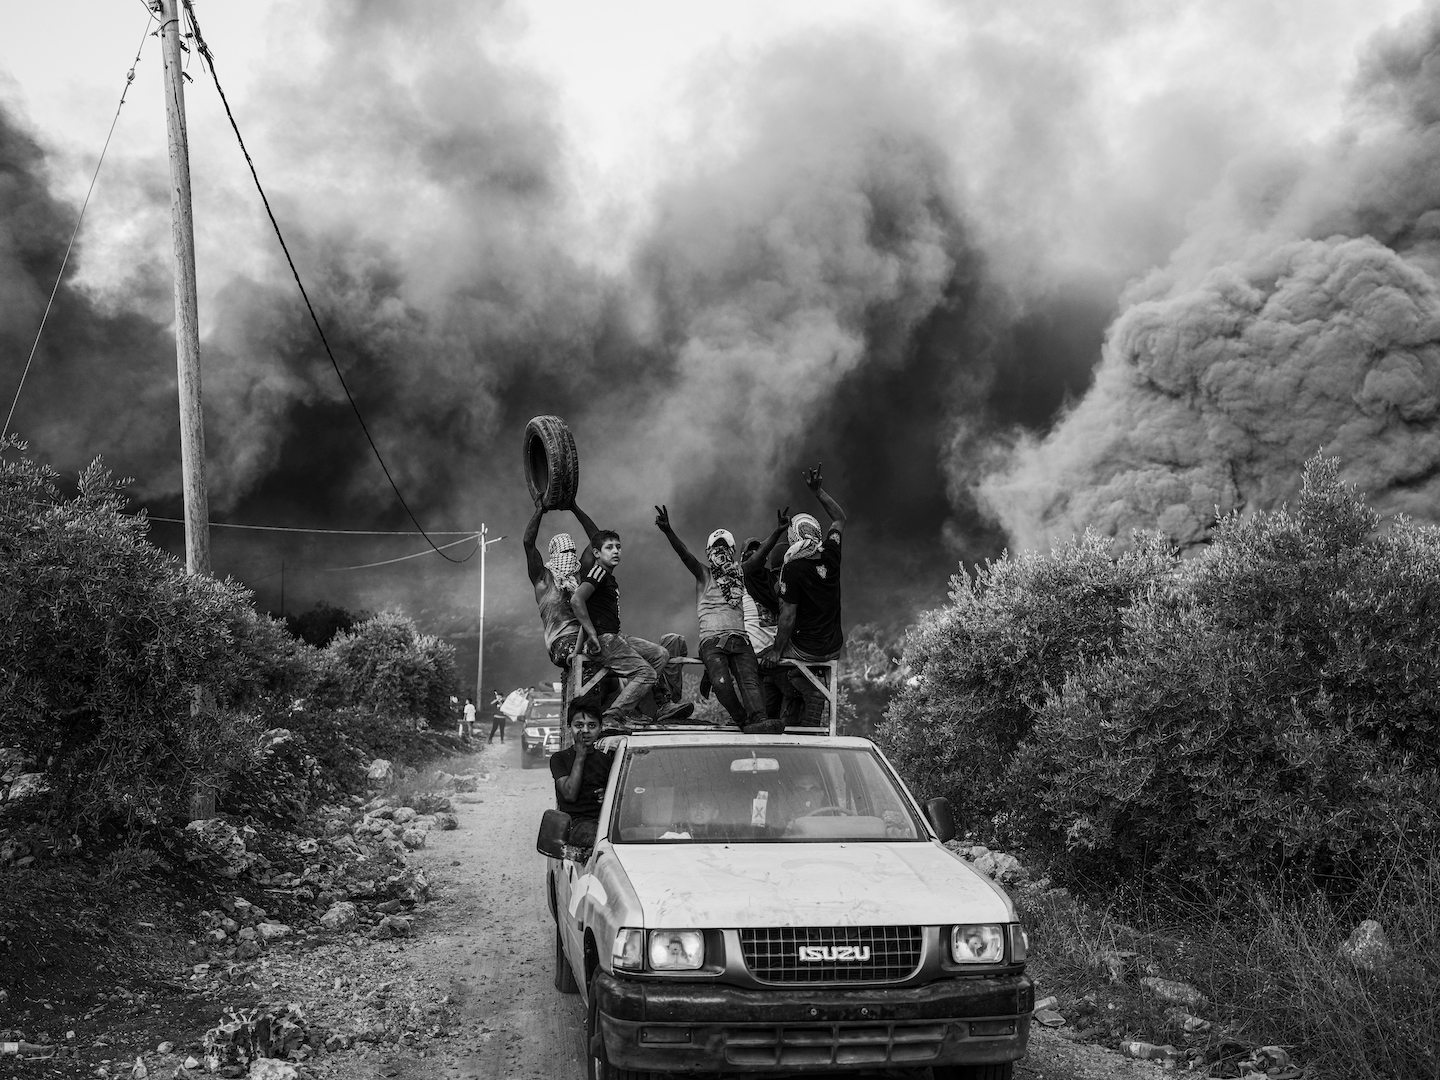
(157, 0, 210, 575)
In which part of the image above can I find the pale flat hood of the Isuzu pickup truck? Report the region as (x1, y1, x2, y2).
(615, 842, 1014, 929)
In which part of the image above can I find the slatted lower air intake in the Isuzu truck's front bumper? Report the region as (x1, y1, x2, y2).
(724, 1022, 945, 1068)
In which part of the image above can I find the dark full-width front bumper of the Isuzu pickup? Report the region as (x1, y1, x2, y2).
(592, 972, 1035, 1073)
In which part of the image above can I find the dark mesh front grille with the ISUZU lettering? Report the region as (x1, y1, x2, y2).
(740, 926, 920, 982)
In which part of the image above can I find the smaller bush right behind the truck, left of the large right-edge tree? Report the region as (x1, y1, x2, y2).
(877, 533, 1175, 840)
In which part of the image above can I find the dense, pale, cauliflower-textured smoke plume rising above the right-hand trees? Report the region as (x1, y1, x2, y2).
(979, 12, 1440, 547)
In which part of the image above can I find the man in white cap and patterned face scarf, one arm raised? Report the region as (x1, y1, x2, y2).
(655, 507, 785, 734)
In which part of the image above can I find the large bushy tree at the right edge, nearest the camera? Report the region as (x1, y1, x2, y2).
(1009, 459, 1440, 890)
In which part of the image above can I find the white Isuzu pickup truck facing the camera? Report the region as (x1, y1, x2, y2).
(537, 729, 1034, 1080)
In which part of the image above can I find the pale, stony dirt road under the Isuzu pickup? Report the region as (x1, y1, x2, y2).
(365, 740, 1161, 1080)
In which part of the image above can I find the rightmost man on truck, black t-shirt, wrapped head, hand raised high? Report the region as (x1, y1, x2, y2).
(765, 465, 845, 727)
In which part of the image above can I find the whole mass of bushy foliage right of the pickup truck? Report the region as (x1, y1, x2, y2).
(884, 458, 1440, 890)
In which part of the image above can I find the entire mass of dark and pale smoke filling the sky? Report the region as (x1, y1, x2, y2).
(0, 0, 1434, 678)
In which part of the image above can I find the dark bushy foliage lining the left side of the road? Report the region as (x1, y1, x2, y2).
(0, 441, 455, 832)
